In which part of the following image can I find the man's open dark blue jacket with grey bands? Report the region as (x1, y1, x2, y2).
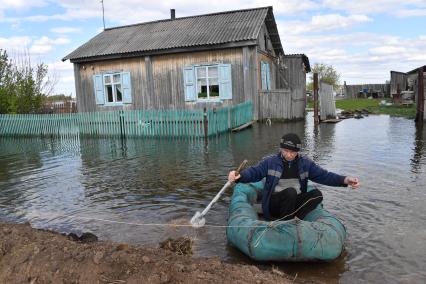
(238, 153, 347, 220)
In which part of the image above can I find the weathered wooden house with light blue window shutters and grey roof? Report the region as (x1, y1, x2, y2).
(63, 7, 310, 119)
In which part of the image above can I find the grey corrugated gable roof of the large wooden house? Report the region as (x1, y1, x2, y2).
(62, 7, 284, 62)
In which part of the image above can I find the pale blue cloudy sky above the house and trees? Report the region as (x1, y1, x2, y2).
(0, 0, 426, 96)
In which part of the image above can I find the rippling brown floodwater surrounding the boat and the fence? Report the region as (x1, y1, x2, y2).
(0, 115, 426, 283)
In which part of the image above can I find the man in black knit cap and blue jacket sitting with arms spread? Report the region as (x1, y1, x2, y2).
(228, 133, 360, 220)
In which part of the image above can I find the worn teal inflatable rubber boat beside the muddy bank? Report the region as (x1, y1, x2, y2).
(226, 182, 346, 261)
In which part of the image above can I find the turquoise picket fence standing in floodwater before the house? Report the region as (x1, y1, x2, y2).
(0, 102, 253, 137)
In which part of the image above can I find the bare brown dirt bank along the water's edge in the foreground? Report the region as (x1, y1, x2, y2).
(0, 223, 306, 284)
